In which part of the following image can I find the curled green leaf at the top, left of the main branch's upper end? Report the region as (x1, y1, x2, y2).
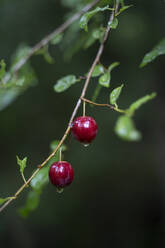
(79, 5, 109, 32)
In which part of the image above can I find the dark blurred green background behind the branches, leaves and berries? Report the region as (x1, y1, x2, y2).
(0, 0, 165, 248)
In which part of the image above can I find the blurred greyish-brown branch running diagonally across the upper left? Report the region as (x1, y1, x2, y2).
(0, 0, 100, 84)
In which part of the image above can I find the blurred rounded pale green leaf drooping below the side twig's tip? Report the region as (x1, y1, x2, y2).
(115, 115, 141, 141)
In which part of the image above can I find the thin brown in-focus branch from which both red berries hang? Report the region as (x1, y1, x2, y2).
(0, 1, 118, 212)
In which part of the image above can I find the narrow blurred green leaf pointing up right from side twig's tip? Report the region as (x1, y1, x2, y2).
(128, 92, 156, 114)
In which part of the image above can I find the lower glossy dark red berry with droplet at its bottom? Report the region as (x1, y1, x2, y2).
(49, 161, 74, 188)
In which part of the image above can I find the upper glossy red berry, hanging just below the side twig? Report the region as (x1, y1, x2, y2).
(71, 116, 98, 144)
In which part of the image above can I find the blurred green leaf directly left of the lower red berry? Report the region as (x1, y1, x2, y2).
(30, 166, 49, 191)
